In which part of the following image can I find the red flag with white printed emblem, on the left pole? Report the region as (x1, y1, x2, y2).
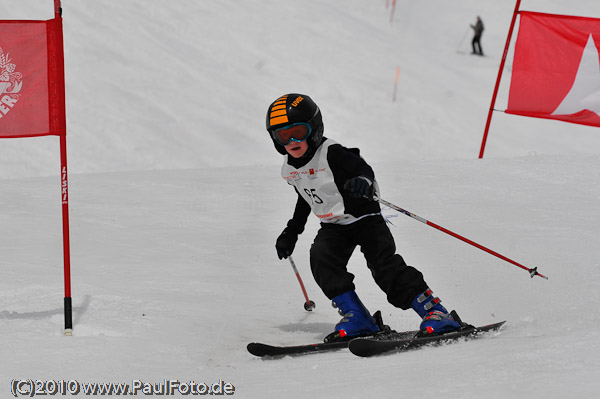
(0, 18, 66, 138)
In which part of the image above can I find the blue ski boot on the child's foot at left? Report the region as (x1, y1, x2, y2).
(325, 291, 381, 342)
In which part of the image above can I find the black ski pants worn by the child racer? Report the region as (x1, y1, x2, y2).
(310, 215, 427, 309)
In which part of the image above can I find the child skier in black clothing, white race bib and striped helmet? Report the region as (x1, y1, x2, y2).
(266, 93, 460, 342)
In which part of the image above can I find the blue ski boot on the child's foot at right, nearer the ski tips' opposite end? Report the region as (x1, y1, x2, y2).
(410, 289, 461, 336)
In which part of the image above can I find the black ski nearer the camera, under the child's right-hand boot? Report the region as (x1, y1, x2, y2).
(348, 321, 505, 357)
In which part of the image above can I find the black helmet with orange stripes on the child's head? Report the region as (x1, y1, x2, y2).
(267, 93, 323, 155)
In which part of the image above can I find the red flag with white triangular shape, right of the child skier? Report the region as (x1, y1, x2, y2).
(506, 11, 600, 127)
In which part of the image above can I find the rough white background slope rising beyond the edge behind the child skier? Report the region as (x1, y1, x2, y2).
(0, 0, 600, 178)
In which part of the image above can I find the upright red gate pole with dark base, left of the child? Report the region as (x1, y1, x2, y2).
(54, 0, 73, 335)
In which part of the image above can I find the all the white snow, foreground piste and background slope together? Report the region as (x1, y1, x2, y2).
(0, 0, 600, 398)
